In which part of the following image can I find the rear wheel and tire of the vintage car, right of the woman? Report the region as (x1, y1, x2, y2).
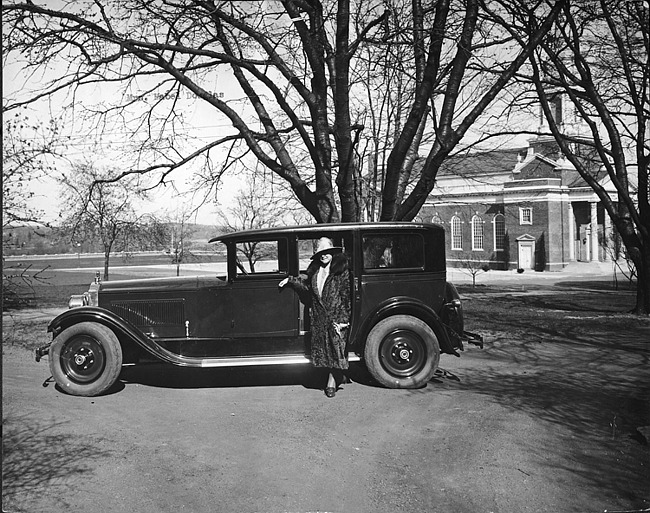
(364, 315, 440, 388)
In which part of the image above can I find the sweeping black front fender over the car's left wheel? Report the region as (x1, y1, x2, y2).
(46, 306, 192, 367)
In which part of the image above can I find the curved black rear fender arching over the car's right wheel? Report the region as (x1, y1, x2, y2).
(353, 296, 460, 356)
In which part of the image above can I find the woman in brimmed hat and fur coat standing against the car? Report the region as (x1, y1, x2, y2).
(279, 237, 350, 397)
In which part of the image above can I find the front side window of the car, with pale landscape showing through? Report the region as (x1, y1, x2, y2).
(235, 239, 289, 277)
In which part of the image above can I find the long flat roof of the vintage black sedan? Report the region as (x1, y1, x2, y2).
(210, 221, 444, 242)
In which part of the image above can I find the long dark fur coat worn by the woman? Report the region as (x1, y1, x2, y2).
(289, 253, 350, 369)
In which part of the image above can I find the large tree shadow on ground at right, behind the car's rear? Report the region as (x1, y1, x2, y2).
(432, 291, 650, 509)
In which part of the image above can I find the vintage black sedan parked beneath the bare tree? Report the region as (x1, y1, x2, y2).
(36, 222, 478, 396)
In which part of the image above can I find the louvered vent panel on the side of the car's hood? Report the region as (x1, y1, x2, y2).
(111, 299, 185, 326)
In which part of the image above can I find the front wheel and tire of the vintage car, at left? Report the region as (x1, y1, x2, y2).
(49, 322, 122, 397)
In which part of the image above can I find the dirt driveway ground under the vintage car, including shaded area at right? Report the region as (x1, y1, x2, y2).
(3, 282, 650, 513)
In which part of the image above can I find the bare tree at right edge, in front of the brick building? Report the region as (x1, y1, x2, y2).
(488, 0, 650, 315)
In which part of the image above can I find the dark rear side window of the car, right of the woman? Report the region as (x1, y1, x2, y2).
(363, 233, 424, 270)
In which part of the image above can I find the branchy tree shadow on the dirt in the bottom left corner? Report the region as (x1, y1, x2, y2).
(2, 414, 109, 512)
